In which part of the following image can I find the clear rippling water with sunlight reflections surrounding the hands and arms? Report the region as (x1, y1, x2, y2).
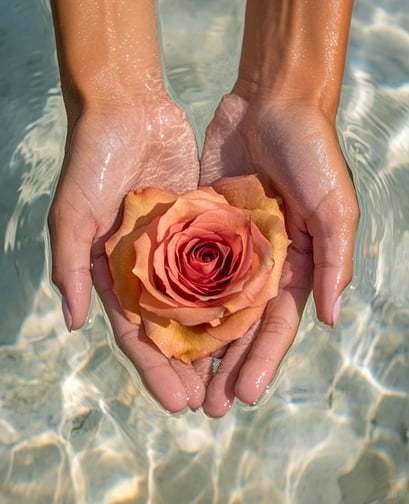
(0, 0, 409, 504)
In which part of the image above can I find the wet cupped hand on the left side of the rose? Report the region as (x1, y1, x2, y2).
(49, 95, 210, 412)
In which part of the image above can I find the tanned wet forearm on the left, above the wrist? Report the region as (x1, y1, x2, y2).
(52, 0, 163, 112)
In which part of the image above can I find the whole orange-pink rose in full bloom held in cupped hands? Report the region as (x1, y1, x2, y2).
(106, 175, 289, 362)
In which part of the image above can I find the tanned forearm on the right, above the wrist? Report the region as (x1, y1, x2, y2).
(235, 0, 353, 117)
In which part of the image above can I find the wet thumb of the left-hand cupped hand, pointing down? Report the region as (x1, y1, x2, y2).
(48, 204, 95, 331)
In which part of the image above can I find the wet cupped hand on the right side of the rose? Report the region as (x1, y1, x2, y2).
(200, 94, 359, 417)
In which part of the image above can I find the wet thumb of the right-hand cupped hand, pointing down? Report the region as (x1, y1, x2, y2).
(307, 189, 359, 327)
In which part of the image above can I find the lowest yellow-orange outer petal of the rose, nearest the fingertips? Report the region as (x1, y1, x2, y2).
(141, 308, 227, 363)
